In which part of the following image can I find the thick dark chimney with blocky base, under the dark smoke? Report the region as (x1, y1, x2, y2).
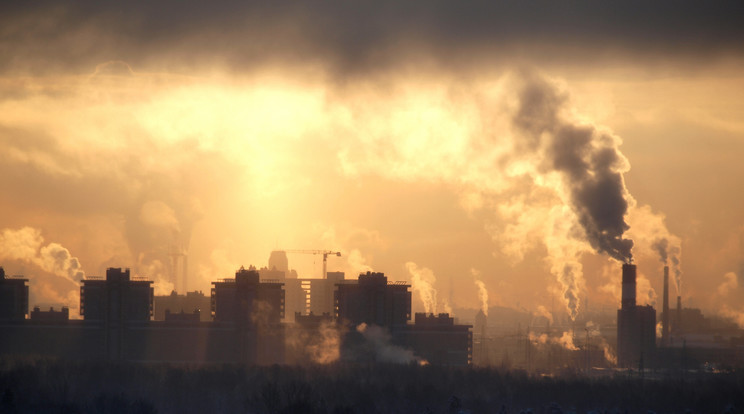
(617, 263, 656, 368)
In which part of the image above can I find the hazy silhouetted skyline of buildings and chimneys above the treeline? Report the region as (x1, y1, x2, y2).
(0, 251, 744, 373)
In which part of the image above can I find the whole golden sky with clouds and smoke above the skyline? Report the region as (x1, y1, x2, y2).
(0, 0, 744, 326)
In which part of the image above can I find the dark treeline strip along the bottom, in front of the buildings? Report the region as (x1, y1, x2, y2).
(0, 359, 744, 414)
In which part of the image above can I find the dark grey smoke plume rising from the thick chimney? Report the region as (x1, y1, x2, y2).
(514, 76, 633, 262)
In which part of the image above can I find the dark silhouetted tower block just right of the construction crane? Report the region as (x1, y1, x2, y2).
(335, 272, 411, 329)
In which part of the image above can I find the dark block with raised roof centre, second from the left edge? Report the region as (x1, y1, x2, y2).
(80, 268, 154, 323)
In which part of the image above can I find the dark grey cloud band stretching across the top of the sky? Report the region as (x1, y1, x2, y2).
(0, 0, 744, 73)
